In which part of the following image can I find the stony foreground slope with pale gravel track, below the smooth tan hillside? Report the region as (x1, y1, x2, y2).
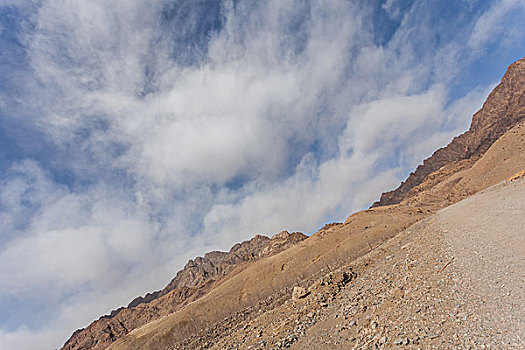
(182, 179, 525, 350)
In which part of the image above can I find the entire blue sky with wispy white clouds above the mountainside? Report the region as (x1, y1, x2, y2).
(0, 0, 525, 349)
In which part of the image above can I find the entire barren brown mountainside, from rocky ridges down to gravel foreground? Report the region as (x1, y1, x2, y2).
(63, 59, 525, 349)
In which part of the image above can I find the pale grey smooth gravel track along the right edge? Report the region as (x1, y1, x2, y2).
(434, 181, 525, 349)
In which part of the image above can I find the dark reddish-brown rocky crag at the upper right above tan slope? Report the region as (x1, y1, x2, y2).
(372, 58, 525, 207)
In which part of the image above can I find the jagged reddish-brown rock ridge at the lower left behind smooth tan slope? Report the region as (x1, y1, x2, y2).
(62, 231, 307, 350)
